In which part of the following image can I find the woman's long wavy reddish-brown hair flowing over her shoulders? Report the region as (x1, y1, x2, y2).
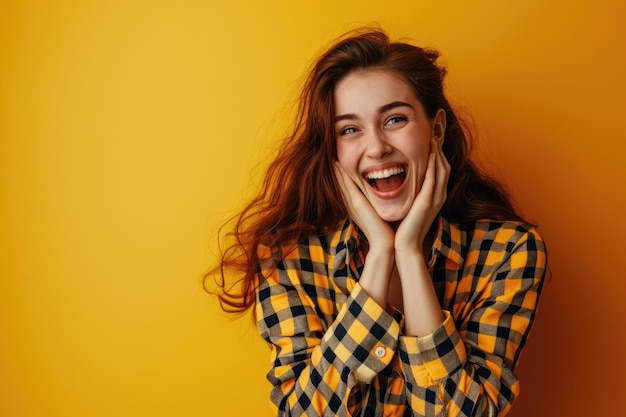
(204, 29, 524, 312)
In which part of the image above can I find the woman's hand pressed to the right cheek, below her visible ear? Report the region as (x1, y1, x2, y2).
(394, 138, 450, 254)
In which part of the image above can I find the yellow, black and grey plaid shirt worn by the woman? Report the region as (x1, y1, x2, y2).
(256, 216, 546, 416)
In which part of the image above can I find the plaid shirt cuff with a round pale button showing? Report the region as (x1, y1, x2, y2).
(324, 283, 400, 383)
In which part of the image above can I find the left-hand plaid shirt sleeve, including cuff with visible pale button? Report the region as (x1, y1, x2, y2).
(256, 249, 400, 416)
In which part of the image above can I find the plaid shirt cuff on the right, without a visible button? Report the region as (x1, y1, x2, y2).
(398, 310, 467, 387)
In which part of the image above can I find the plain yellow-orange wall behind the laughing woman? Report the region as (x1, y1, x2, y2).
(0, 0, 626, 417)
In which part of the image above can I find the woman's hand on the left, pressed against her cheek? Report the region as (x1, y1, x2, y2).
(335, 162, 394, 253)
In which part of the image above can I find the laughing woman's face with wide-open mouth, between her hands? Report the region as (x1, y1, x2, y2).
(334, 70, 445, 222)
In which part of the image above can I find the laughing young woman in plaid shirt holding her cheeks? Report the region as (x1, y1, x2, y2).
(207, 30, 546, 416)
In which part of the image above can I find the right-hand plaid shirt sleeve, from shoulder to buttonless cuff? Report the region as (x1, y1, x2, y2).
(398, 230, 546, 417)
